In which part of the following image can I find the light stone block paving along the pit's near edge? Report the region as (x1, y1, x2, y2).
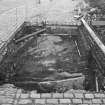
(0, 87, 105, 105)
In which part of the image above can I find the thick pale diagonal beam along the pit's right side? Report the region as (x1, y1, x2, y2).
(81, 18, 105, 54)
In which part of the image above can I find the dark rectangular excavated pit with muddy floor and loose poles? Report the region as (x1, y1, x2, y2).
(0, 24, 94, 93)
